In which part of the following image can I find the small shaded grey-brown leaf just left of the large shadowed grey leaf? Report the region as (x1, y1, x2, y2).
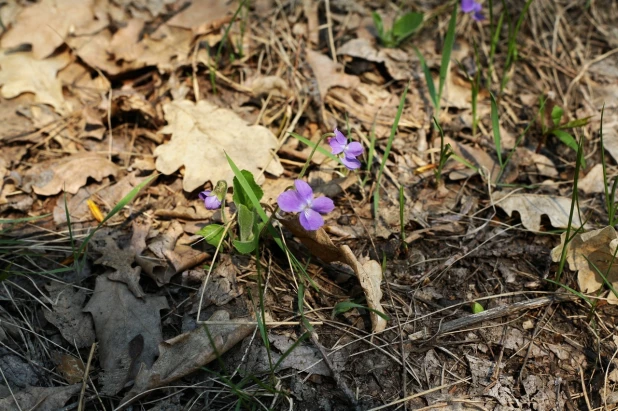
(43, 282, 95, 348)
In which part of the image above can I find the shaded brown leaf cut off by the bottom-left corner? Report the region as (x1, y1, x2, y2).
(0, 384, 82, 411)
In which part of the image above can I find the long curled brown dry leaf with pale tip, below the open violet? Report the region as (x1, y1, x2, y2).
(279, 218, 386, 332)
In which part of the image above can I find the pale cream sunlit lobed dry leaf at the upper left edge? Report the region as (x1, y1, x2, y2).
(0, 52, 71, 114)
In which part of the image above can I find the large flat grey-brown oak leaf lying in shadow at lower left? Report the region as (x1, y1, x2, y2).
(84, 274, 168, 393)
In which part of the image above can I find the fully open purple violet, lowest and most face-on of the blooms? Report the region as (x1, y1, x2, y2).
(277, 180, 335, 231)
